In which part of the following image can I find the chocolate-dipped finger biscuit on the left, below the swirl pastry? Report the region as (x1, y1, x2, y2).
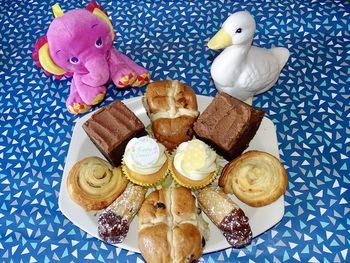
(98, 185, 145, 244)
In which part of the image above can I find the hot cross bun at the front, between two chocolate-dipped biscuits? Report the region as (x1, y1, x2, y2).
(138, 187, 209, 263)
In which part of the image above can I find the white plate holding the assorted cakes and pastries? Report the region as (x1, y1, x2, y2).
(59, 95, 284, 253)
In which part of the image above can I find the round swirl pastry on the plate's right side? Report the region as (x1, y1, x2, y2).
(219, 151, 288, 207)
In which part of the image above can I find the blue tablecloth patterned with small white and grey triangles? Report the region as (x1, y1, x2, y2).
(0, 0, 350, 262)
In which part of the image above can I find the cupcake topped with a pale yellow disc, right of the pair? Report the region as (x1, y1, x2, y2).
(171, 139, 218, 189)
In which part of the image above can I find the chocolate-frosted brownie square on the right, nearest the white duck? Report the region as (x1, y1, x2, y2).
(193, 92, 265, 160)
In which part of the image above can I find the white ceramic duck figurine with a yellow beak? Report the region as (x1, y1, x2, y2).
(208, 11, 289, 100)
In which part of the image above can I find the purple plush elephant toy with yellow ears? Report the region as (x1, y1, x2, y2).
(33, 2, 150, 114)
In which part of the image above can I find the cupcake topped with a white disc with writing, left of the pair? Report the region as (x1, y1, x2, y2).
(122, 136, 169, 187)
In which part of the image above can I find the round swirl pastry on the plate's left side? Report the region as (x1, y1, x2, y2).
(67, 157, 128, 210)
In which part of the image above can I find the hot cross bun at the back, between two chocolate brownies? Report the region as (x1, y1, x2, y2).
(142, 80, 199, 150)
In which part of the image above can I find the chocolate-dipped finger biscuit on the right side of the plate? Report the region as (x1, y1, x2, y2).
(198, 186, 252, 248)
